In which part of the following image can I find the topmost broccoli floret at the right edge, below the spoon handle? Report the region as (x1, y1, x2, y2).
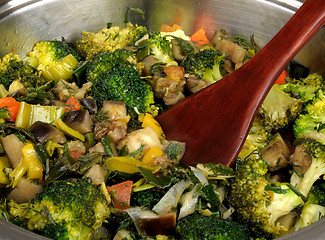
(280, 73, 324, 102)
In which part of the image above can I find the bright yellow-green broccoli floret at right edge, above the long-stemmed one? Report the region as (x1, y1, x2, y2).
(293, 89, 325, 144)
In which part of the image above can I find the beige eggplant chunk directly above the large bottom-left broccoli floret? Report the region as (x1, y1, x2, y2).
(8, 177, 43, 204)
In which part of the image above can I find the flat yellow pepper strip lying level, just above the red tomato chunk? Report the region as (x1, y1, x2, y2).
(104, 157, 159, 173)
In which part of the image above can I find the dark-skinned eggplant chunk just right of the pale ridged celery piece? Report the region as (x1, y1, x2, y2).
(62, 109, 93, 134)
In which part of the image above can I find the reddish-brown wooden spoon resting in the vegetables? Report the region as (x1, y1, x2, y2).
(157, 0, 325, 166)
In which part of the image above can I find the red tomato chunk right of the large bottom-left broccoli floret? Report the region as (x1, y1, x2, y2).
(107, 181, 133, 210)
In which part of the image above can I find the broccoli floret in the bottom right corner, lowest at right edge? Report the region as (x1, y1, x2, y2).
(294, 183, 325, 230)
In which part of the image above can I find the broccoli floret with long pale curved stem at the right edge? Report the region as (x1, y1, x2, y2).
(292, 138, 325, 197)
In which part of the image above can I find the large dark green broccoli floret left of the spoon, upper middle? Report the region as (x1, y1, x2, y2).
(87, 49, 158, 120)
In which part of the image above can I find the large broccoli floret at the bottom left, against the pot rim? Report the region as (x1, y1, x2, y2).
(3, 179, 110, 240)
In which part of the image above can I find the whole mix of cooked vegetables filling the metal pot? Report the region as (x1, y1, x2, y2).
(0, 14, 325, 240)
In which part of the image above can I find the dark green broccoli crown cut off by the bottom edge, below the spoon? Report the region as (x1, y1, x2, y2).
(176, 214, 251, 240)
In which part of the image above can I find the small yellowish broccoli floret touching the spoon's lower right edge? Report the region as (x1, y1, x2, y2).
(238, 116, 272, 159)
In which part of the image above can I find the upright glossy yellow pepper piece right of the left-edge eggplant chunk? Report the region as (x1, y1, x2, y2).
(21, 143, 44, 181)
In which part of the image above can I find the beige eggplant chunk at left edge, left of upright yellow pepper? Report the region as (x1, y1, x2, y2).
(1, 134, 24, 168)
